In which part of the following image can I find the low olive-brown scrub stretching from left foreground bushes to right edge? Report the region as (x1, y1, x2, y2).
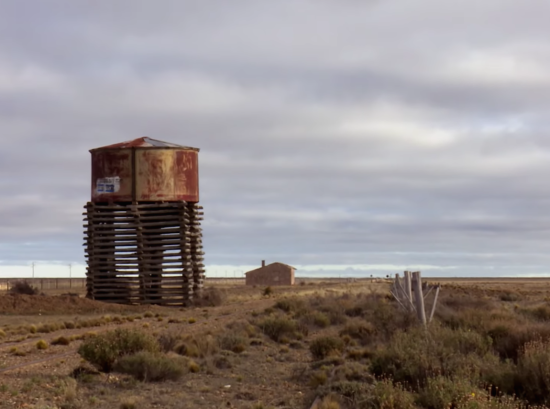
(70, 282, 550, 409)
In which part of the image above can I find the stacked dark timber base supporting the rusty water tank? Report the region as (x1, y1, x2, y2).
(84, 202, 204, 305)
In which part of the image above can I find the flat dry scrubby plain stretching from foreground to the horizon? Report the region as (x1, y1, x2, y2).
(0, 278, 550, 409)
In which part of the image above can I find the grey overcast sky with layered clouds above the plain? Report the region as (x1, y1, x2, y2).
(0, 0, 550, 276)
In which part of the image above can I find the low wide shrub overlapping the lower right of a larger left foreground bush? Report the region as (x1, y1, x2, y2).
(115, 351, 187, 382)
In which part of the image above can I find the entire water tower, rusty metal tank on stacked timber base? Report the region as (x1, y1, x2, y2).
(84, 137, 204, 305)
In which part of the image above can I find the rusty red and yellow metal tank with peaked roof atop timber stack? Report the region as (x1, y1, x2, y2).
(90, 136, 199, 203)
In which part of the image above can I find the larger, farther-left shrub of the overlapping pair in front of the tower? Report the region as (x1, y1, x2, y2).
(78, 328, 159, 372)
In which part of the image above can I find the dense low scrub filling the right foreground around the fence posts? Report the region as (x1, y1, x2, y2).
(264, 289, 550, 409)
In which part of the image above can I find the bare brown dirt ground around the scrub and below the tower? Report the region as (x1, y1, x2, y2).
(0, 279, 550, 409)
